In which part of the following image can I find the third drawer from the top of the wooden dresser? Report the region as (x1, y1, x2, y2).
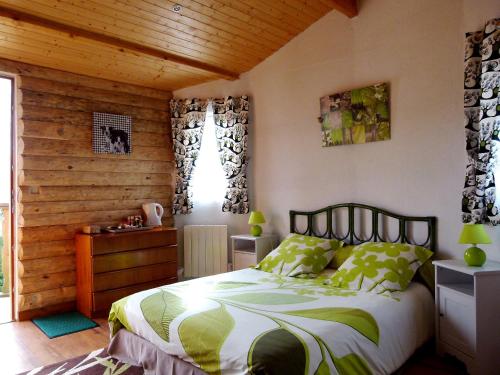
(93, 262, 177, 292)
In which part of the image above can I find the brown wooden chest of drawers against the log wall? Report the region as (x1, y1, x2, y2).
(75, 227, 177, 317)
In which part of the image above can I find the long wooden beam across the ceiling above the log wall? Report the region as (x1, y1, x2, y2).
(0, 6, 239, 80)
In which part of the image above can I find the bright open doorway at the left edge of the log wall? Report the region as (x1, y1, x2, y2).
(0, 76, 14, 324)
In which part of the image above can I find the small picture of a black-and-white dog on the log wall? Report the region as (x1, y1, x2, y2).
(92, 112, 132, 154)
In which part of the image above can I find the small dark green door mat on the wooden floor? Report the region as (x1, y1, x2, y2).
(32, 312, 99, 339)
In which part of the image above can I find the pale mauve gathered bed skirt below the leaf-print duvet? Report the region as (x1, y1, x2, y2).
(108, 329, 206, 375)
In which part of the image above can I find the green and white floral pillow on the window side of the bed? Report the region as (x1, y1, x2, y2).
(255, 233, 343, 278)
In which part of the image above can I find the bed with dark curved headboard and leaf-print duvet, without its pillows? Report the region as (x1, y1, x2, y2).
(108, 203, 436, 375)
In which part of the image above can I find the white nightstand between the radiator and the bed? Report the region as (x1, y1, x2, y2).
(231, 234, 278, 271)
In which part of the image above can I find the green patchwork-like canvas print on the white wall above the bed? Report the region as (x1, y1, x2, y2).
(320, 83, 391, 147)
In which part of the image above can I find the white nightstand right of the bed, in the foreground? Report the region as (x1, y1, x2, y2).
(432, 259, 500, 375)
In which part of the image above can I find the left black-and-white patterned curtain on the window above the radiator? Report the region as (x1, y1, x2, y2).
(170, 99, 207, 215)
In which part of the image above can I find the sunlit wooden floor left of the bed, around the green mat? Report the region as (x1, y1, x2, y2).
(0, 319, 109, 375)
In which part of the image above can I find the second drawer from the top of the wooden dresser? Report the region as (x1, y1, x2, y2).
(92, 246, 177, 273)
